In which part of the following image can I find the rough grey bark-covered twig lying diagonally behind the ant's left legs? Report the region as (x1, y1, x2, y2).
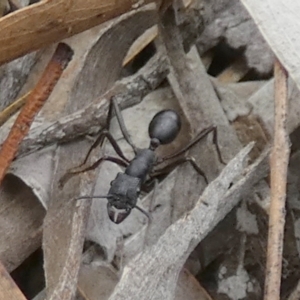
(10, 54, 169, 155)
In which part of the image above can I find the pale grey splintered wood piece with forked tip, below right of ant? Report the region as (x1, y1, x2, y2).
(109, 144, 269, 300)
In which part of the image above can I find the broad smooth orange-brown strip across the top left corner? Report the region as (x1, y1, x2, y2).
(0, 0, 158, 65)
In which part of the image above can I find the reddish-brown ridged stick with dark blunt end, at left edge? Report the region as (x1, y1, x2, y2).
(0, 43, 73, 183)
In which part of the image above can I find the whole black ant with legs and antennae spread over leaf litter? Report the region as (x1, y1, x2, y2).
(61, 98, 220, 224)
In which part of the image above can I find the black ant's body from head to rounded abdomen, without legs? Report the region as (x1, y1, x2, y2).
(106, 110, 181, 224)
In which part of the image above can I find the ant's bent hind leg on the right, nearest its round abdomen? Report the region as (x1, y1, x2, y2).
(156, 126, 225, 165)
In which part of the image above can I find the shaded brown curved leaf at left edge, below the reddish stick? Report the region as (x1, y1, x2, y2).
(0, 175, 45, 272)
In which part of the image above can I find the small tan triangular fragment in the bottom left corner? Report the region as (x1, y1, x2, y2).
(0, 261, 26, 300)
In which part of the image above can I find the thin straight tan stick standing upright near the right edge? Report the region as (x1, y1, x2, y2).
(264, 61, 290, 300)
